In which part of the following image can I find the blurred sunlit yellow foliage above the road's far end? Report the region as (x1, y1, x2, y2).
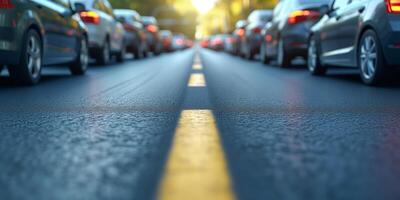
(110, 0, 278, 39)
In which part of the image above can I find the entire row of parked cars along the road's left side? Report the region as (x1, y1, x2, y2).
(0, 0, 192, 85)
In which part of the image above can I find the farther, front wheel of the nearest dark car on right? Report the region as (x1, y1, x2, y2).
(307, 37, 327, 75)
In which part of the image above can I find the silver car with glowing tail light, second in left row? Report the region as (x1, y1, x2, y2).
(74, 0, 126, 65)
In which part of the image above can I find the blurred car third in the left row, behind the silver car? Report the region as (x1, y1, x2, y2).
(114, 9, 148, 59)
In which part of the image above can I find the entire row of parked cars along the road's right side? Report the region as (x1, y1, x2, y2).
(201, 0, 400, 85)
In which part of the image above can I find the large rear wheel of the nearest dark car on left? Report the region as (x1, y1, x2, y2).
(8, 29, 43, 85)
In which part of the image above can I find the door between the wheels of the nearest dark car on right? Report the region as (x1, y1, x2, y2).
(321, 0, 352, 65)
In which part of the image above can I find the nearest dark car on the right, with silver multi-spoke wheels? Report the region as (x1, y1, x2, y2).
(308, 0, 400, 85)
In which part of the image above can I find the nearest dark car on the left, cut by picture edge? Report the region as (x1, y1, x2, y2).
(0, 0, 89, 85)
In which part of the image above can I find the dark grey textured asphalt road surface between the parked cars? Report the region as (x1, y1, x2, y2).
(0, 50, 400, 200)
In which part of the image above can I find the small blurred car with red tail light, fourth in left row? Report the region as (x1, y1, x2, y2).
(142, 16, 162, 55)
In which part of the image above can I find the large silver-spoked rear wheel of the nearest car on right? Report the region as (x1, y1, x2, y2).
(358, 30, 389, 85)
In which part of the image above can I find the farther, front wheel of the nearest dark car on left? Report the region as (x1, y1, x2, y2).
(69, 37, 89, 75)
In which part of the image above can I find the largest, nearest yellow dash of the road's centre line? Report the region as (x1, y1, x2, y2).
(158, 110, 235, 200)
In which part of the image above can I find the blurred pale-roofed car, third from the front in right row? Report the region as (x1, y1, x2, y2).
(240, 10, 272, 60)
